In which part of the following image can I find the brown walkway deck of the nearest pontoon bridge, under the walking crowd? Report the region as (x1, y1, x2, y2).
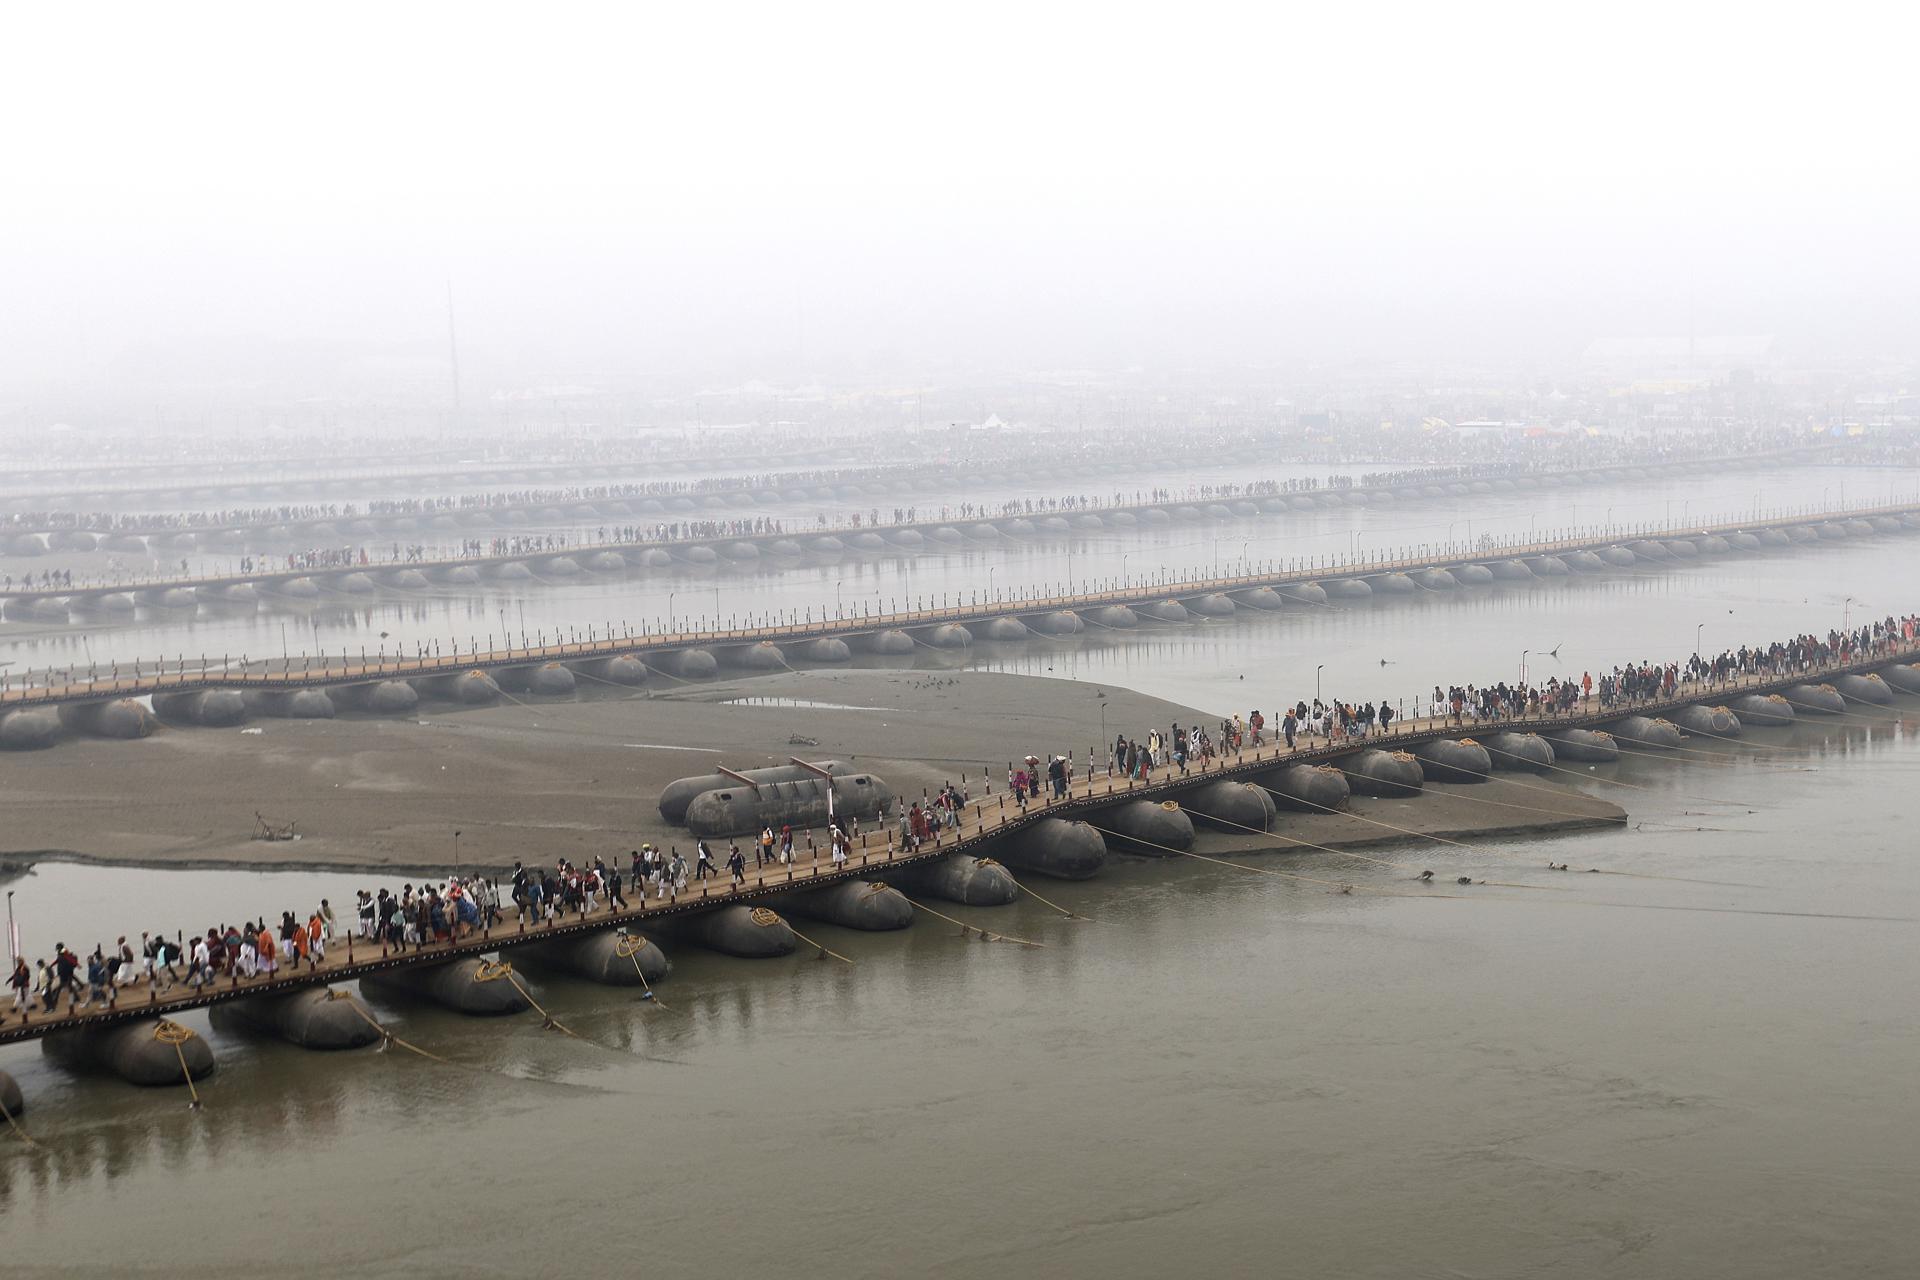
(0, 647, 1920, 1044)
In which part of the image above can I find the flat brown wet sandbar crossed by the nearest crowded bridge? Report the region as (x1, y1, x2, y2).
(0, 670, 1620, 871)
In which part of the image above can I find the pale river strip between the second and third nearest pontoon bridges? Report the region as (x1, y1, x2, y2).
(0, 468, 1920, 679)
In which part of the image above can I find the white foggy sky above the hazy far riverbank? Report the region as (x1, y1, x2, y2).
(0, 4, 1920, 401)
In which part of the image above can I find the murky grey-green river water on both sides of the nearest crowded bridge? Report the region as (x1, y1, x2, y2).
(0, 466, 1920, 1278)
